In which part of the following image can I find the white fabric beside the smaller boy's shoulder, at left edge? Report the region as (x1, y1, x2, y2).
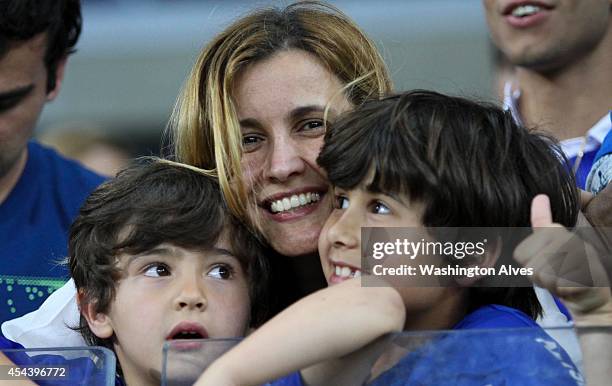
(2, 279, 87, 348)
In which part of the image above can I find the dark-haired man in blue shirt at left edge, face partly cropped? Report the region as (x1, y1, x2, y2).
(0, 0, 103, 322)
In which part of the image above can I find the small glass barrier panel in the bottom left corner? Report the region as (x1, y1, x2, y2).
(0, 346, 116, 386)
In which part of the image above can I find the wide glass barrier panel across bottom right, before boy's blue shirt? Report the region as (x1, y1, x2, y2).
(162, 327, 612, 386)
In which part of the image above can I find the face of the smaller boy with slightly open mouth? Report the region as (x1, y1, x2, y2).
(88, 240, 250, 383)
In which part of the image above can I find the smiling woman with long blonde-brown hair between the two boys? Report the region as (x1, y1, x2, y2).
(171, 1, 391, 307)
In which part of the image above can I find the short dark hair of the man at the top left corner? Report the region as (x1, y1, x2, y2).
(0, 0, 82, 92)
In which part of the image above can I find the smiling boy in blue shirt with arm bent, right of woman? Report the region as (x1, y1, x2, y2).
(198, 91, 583, 385)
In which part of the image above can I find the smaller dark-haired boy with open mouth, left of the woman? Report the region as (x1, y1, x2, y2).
(69, 161, 265, 385)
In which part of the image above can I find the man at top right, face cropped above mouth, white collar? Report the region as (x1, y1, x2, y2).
(483, 0, 612, 189)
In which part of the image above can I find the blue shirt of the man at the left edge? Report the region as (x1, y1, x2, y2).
(0, 141, 104, 323)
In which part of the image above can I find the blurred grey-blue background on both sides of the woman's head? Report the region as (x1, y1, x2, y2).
(37, 0, 498, 175)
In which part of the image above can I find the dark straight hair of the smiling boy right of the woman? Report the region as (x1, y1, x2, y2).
(317, 90, 579, 318)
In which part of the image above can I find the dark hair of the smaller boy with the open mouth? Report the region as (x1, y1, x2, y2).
(68, 161, 268, 349)
